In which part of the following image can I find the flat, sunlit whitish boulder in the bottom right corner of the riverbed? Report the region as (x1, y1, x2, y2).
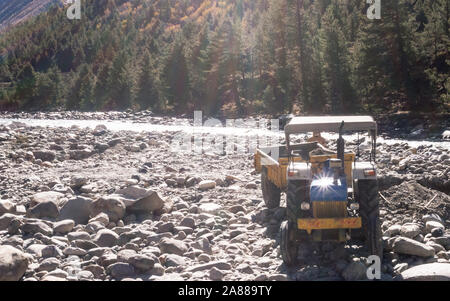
(399, 262, 450, 281)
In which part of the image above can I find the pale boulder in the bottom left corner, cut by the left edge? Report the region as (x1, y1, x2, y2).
(0, 245, 31, 281)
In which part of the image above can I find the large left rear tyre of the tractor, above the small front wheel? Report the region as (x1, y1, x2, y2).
(286, 180, 309, 225)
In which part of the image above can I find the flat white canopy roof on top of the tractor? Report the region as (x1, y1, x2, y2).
(284, 116, 377, 135)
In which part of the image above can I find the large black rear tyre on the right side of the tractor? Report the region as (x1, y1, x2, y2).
(358, 180, 383, 259)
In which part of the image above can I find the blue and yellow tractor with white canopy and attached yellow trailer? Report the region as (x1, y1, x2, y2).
(254, 116, 383, 265)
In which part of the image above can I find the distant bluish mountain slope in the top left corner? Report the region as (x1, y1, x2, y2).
(0, 0, 60, 32)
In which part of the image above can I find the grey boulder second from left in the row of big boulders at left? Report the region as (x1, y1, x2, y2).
(58, 196, 92, 224)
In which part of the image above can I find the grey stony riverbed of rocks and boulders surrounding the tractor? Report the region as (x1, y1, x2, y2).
(0, 113, 450, 281)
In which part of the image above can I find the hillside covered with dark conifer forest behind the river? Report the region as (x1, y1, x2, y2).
(0, 0, 450, 116)
